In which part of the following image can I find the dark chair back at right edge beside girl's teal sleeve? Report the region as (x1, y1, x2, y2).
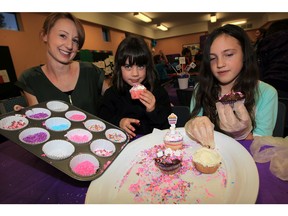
(273, 100, 287, 137)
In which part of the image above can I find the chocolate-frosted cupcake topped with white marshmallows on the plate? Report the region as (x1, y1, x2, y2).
(154, 148, 182, 175)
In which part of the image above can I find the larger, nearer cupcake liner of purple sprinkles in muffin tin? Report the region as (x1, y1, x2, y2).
(19, 127, 50, 145)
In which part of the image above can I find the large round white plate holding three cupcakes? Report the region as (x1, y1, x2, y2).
(85, 128, 259, 204)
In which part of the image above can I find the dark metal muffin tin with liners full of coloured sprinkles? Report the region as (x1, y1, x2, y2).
(0, 101, 129, 181)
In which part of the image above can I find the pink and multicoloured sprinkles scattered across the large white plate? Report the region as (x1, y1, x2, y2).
(115, 144, 227, 204)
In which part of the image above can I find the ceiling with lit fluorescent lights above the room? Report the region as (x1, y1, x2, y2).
(74, 12, 288, 39)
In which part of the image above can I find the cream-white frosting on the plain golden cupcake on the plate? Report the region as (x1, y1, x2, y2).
(193, 147, 221, 167)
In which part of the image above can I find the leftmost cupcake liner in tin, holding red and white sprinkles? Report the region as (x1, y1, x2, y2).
(0, 116, 29, 131)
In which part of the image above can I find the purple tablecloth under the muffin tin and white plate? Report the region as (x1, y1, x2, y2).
(0, 141, 288, 204)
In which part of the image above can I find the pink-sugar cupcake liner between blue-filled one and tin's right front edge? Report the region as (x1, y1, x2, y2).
(65, 128, 93, 144)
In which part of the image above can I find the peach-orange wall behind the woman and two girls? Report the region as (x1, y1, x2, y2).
(0, 13, 260, 79)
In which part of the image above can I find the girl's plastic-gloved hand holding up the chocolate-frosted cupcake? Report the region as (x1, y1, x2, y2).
(216, 101, 252, 140)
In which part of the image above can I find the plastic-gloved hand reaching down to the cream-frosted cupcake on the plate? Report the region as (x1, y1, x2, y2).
(185, 116, 215, 149)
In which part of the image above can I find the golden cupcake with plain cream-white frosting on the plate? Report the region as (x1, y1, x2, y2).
(192, 147, 221, 174)
